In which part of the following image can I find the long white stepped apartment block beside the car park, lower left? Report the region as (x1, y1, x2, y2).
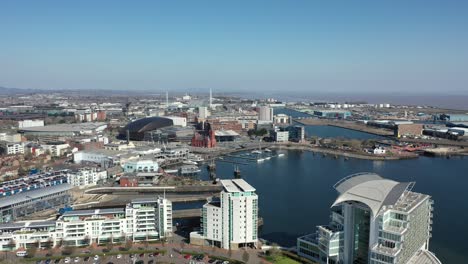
(0, 198, 172, 250)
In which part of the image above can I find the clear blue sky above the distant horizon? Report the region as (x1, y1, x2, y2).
(0, 0, 468, 93)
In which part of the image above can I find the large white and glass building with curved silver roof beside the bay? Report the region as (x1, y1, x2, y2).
(297, 173, 441, 264)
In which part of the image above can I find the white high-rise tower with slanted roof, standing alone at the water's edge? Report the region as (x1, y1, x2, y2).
(190, 179, 258, 249)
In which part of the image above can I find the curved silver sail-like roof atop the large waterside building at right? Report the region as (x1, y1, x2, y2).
(332, 172, 414, 217)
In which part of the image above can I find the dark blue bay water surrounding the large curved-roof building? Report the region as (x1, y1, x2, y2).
(202, 151, 468, 263)
